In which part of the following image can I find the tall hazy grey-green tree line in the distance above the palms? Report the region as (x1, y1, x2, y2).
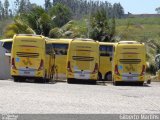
(0, 0, 124, 19)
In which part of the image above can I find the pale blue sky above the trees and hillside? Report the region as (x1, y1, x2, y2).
(2, 0, 160, 14)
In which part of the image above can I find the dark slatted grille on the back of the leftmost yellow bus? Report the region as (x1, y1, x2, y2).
(16, 52, 39, 58)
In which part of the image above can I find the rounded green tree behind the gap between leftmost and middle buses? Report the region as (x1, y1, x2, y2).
(50, 3, 71, 27)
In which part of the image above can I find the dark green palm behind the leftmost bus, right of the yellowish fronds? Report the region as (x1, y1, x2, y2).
(17, 4, 51, 36)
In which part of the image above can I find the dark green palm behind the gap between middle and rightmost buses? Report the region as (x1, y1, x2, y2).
(90, 8, 115, 42)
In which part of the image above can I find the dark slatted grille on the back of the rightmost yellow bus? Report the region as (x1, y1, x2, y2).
(119, 59, 141, 64)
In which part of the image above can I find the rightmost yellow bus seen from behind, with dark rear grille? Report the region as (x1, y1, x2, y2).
(113, 41, 146, 85)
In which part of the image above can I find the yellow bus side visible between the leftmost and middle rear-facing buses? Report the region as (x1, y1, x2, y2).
(48, 38, 72, 80)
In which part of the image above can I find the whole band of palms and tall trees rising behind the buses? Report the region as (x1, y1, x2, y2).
(0, 0, 124, 41)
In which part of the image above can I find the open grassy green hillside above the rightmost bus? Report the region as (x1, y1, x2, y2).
(116, 18, 160, 41)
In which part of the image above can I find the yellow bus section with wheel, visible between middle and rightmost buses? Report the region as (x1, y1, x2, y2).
(98, 42, 114, 81)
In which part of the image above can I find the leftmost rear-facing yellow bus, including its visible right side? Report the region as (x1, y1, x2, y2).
(11, 34, 54, 82)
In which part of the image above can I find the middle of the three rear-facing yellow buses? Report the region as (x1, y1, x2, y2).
(67, 38, 99, 83)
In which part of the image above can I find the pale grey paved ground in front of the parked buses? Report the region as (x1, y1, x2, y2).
(0, 80, 160, 114)
